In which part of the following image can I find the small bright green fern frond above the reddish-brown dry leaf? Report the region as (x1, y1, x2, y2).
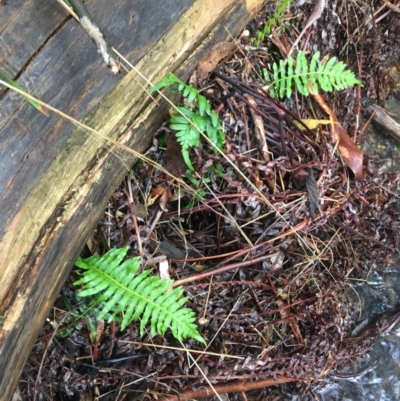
(264, 51, 362, 97)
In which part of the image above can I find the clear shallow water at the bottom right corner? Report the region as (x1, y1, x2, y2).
(315, 272, 400, 401)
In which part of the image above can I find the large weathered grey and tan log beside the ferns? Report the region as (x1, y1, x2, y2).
(0, 0, 264, 400)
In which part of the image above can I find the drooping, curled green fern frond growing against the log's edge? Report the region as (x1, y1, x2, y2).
(150, 73, 225, 171)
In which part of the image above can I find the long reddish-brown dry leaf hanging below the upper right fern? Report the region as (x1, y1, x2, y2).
(310, 91, 364, 180)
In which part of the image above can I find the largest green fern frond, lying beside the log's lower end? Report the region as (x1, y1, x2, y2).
(74, 248, 206, 344)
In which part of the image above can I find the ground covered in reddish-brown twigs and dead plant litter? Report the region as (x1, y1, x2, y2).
(20, 0, 400, 401)
